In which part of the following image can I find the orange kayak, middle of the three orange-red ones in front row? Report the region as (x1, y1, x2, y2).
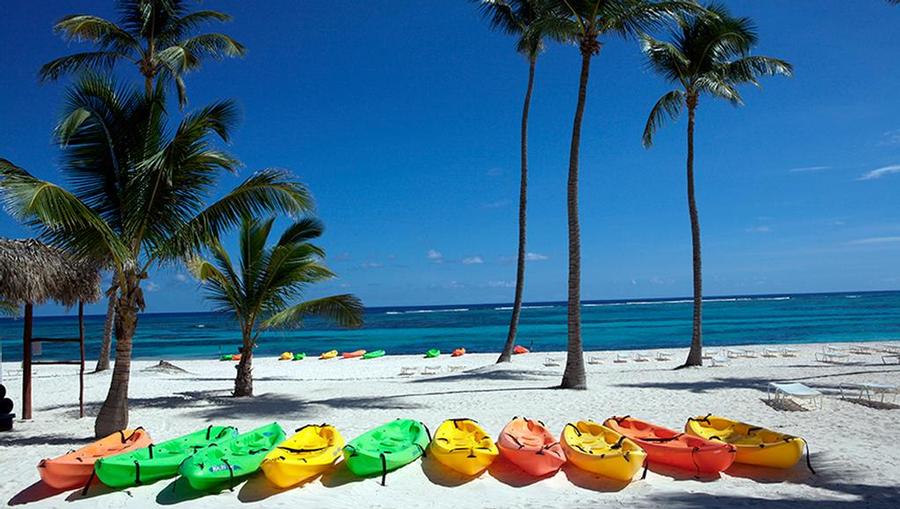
(497, 417, 566, 477)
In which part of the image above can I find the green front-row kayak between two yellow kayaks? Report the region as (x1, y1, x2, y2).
(344, 419, 431, 484)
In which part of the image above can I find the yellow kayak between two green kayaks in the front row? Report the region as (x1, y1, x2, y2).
(260, 424, 344, 488)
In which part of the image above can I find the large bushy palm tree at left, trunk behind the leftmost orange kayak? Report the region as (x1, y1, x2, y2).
(0, 75, 311, 436)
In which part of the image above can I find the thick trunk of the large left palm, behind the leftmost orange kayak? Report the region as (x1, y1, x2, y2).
(94, 277, 140, 438)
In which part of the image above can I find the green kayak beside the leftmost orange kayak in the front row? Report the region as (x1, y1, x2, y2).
(94, 426, 237, 488)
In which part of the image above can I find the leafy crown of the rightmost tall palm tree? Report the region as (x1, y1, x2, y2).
(641, 4, 793, 147)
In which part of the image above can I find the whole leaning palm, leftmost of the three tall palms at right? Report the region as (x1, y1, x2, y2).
(479, 0, 556, 363)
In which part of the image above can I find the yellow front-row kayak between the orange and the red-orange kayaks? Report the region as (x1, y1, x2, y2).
(560, 421, 647, 482)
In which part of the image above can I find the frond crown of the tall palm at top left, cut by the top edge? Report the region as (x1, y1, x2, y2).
(39, 0, 246, 108)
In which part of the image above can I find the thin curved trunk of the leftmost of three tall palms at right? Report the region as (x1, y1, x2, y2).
(497, 57, 537, 363)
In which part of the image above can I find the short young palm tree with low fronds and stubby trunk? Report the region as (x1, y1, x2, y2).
(189, 218, 363, 397)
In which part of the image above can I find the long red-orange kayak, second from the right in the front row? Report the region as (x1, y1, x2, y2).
(604, 416, 736, 474)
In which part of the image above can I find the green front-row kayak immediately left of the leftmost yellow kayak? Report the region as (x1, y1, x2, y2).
(178, 422, 284, 491)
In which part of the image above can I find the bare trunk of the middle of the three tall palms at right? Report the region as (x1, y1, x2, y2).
(560, 49, 592, 389)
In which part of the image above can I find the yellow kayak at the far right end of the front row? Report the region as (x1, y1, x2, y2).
(684, 415, 812, 470)
